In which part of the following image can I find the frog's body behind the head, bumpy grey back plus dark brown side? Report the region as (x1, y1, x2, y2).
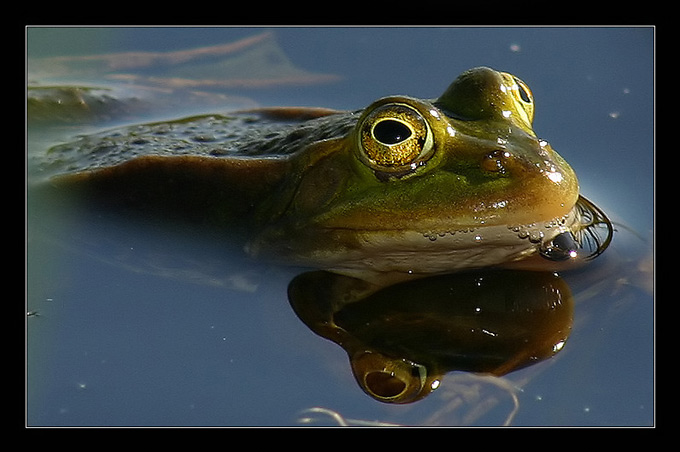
(30, 108, 356, 228)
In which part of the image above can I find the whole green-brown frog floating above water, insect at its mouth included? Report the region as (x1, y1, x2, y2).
(38, 67, 612, 277)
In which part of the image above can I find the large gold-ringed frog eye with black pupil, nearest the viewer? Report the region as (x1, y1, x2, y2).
(358, 103, 434, 173)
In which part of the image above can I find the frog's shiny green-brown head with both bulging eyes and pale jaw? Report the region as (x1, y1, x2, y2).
(254, 68, 596, 272)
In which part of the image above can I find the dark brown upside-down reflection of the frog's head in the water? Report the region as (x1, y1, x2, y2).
(288, 270, 573, 403)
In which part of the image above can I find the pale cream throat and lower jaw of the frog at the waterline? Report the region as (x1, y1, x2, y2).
(249, 199, 608, 275)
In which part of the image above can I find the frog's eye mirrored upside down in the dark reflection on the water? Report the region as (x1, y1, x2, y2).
(352, 351, 439, 403)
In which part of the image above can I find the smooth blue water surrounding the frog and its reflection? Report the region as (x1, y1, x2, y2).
(26, 28, 655, 426)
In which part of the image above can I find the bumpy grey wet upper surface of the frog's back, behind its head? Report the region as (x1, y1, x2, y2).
(36, 108, 356, 178)
